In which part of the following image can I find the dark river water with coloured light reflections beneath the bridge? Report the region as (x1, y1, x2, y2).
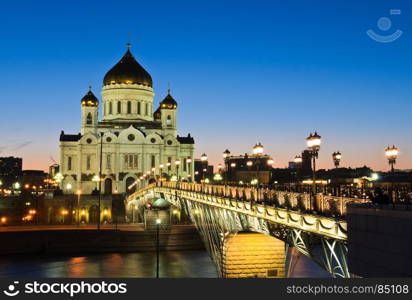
(0, 251, 328, 278)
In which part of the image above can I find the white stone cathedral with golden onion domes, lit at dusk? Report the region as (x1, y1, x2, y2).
(60, 44, 194, 194)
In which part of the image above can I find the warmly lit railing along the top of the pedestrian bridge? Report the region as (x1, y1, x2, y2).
(130, 182, 369, 217)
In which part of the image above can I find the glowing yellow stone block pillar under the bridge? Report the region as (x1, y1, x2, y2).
(222, 232, 286, 278)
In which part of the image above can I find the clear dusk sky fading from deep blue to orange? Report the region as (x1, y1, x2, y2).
(0, 0, 412, 170)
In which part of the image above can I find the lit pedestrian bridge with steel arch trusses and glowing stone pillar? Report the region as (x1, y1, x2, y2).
(127, 182, 366, 277)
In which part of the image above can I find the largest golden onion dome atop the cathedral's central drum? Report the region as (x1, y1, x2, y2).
(103, 45, 152, 87)
